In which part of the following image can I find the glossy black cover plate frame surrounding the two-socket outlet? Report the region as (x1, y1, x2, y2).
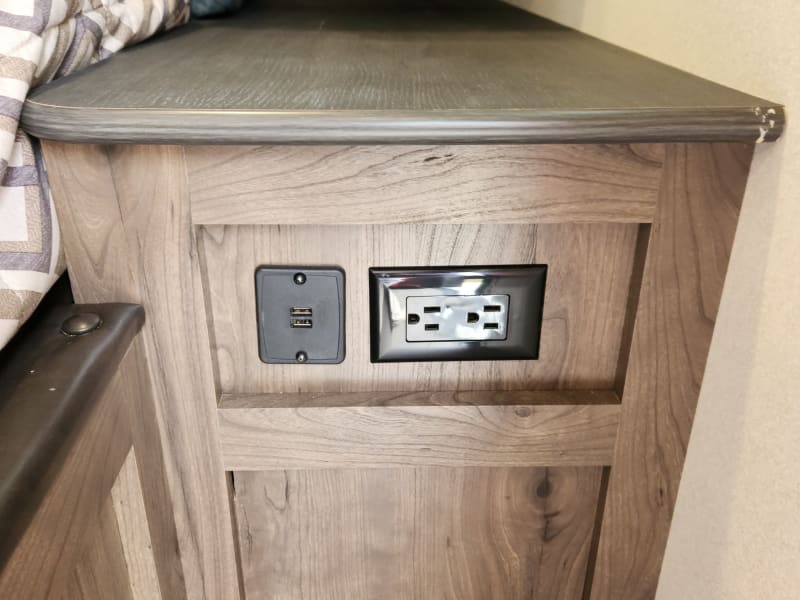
(369, 265, 547, 363)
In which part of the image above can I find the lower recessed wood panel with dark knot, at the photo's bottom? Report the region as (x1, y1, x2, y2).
(234, 468, 601, 600)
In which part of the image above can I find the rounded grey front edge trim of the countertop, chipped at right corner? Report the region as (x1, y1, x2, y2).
(21, 100, 785, 144)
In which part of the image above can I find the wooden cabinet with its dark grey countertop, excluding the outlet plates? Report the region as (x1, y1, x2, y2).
(21, 4, 782, 600)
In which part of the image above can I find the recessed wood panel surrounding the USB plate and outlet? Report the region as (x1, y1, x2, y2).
(199, 223, 638, 394)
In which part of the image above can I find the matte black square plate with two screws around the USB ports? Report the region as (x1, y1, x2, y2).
(255, 266, 345, 364)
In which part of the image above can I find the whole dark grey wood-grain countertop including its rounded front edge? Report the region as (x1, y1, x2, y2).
(22, 1, 784, 144)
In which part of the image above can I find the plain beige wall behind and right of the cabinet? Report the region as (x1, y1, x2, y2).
(506, 0, 800, 600)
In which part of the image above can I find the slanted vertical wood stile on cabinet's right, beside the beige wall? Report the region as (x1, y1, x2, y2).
(591, 144, 752, 600)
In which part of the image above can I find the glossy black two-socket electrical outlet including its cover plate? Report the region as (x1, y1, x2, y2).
(370, 265, 547, 362)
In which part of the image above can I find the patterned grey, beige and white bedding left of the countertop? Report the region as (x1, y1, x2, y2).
(0, 0, 189, 348)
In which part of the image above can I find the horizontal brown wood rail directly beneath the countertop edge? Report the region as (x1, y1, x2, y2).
(186, 144, 664, 225)
